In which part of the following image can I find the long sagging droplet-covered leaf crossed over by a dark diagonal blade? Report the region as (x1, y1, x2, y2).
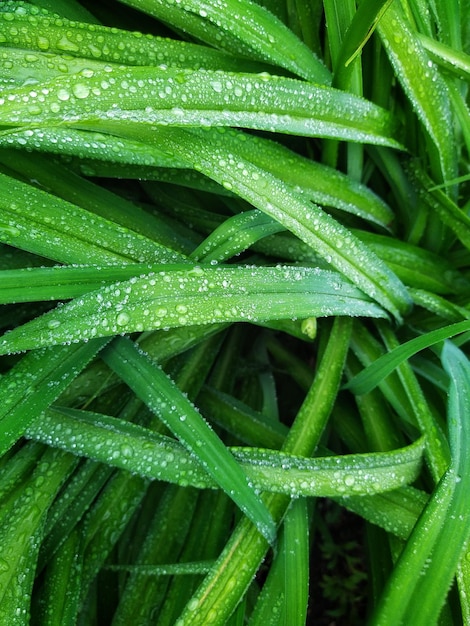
(26, 407, 424, 497)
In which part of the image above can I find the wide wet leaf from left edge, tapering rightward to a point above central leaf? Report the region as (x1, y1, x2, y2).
(0, 173, 184, 265)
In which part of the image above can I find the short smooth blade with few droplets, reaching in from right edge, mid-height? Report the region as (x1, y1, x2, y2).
(344, 321, 470, 395)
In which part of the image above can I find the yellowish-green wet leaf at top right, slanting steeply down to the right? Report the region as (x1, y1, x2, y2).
(378, 2, 457, 182)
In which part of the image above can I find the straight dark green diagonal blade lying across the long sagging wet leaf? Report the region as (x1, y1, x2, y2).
(103, 339, 276, 543)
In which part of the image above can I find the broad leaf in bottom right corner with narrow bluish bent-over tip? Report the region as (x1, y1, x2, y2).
(372, 342, 470, 626)
